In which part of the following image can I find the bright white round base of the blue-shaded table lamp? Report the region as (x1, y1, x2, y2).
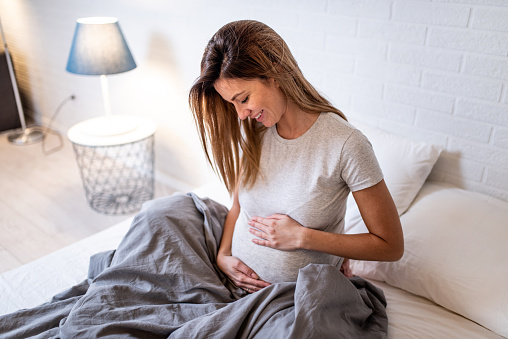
(81, 116, 138, 137)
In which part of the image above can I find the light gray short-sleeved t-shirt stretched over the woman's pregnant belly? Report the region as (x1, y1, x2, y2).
(232, 113, 383, 283)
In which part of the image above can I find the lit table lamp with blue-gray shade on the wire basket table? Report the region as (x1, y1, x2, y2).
(66, 17, 136, 137)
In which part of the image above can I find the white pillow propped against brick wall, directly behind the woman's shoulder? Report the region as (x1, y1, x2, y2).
(344, 121, 441, 233)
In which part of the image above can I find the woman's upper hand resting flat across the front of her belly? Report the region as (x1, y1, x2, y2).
(249, 214, 305, 251)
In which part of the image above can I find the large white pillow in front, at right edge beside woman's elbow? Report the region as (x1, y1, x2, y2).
(351, 183, 508, 337)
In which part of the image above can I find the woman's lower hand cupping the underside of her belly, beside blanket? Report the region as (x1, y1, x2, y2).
(217, 253, 270, 293)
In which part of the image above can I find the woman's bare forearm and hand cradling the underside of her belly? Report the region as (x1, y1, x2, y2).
(217, 191, 270, 292)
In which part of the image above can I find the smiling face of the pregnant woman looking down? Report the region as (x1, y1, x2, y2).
(214, 78, 287, 127)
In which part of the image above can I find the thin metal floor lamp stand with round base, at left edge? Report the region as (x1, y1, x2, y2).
(0, 14, 44, 145)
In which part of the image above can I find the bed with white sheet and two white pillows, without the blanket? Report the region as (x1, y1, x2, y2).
(0, 122, 508, 338)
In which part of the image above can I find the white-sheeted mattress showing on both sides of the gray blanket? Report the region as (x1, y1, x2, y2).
(0, 203, 502, 338)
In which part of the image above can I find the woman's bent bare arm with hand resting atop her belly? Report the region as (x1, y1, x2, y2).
(250, 180, 404, 261)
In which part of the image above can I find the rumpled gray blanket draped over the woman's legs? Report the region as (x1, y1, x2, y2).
(0, 194, 388, 338)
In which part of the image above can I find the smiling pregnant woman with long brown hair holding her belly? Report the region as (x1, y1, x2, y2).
(189, 20, 404, 293)
